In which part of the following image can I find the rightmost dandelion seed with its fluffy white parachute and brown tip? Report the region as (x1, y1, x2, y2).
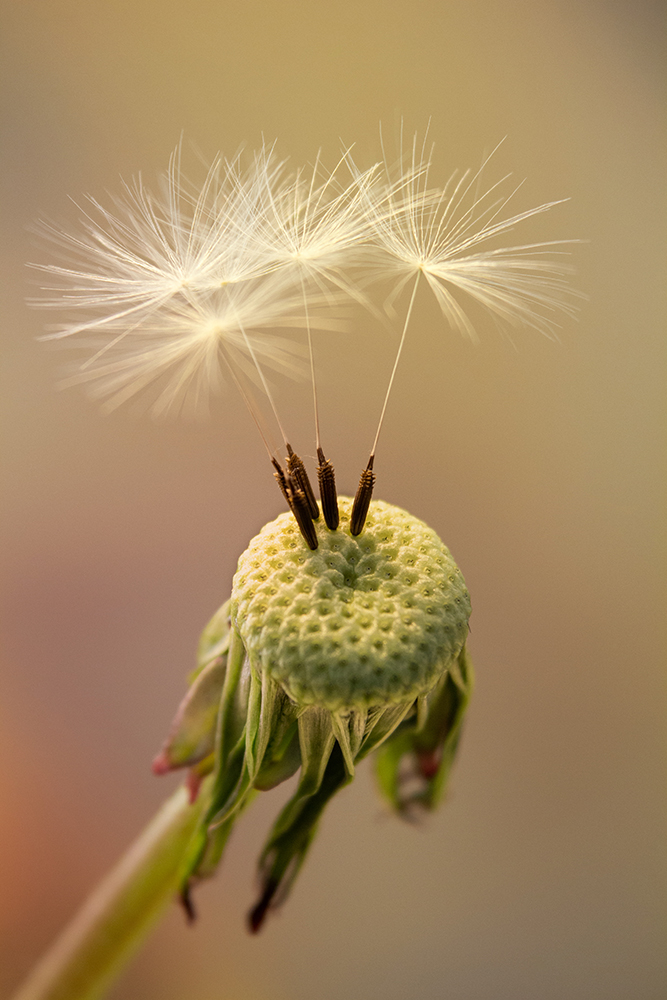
(350, 136, 576, 531)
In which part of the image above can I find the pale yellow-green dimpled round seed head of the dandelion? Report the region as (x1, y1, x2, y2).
(232, 497, 470, 711)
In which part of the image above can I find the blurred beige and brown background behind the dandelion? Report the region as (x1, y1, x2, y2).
(0, 0, 667, 1000)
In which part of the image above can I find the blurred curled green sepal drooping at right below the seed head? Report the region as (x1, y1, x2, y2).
(376, 646, 473, 816)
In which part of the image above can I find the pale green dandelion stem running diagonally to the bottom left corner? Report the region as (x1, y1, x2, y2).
(12, 788, 207, 1000)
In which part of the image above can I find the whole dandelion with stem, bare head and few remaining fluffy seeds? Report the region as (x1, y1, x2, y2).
(17, 133, 573, 1000)
